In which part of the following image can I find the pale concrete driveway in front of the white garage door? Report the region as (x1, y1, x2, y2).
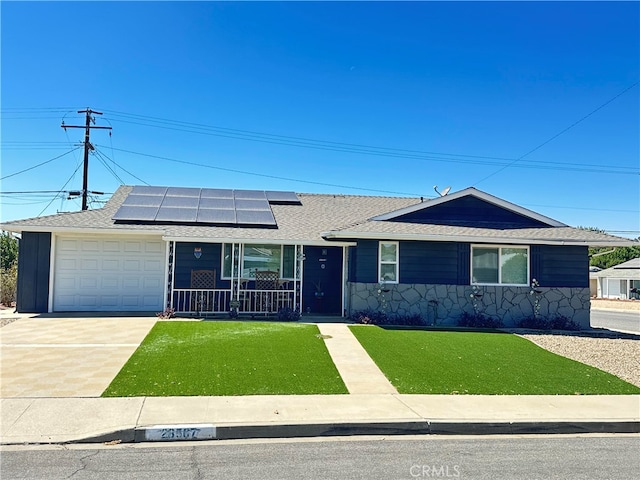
(0, 316, 157, 398)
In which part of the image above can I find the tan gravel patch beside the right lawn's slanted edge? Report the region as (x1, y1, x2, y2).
(514, 332, 640, 387)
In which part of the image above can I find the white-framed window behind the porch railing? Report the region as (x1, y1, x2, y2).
(221, 243, 296, 280)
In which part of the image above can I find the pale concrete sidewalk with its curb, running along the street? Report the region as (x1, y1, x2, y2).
(0, 394, 640, 444)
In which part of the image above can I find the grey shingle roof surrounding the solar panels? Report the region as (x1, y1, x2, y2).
(2, 182, 635, 246)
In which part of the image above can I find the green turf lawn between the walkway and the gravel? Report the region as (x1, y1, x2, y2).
(350, 326, 640, 395)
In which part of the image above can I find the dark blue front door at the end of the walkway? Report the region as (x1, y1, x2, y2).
(302, 247, 342, 315)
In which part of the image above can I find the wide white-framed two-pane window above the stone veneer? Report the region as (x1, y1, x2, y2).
(471, 245, 529, 286)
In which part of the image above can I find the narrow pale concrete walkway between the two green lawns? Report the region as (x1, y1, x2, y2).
(318, 323, 398, 395)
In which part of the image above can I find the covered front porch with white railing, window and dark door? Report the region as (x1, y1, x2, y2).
(166, 241, 344, 316)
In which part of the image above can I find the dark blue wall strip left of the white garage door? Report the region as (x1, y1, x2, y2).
(16, 232, 51, 313)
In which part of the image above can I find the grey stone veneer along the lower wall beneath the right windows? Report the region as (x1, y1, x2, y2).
(349, 282, 590, 329)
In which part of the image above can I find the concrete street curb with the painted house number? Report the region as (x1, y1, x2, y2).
(33, 420, 640, 445)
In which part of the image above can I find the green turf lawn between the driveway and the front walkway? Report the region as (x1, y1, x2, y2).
(102, 322, 347, 397)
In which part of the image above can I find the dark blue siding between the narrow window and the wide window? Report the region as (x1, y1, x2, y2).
(400, 242, 459, 285)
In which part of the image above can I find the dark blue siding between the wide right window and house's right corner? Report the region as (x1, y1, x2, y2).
(531, 245, 589, 288)
